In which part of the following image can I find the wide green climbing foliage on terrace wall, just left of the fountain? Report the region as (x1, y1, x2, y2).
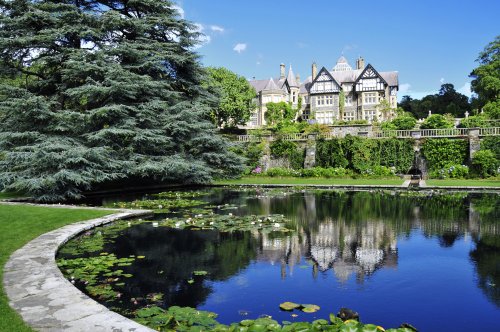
(316, 136, 414, 175)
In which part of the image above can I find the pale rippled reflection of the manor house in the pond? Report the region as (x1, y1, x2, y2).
(257, 220, 397, 282)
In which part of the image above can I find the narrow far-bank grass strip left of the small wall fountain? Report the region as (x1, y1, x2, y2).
(215, 176, 403, 186)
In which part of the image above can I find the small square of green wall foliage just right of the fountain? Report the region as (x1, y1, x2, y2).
(422, 138, 469, 170)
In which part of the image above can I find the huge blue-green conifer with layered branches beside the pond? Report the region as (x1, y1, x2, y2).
(0, 0, 241, 201)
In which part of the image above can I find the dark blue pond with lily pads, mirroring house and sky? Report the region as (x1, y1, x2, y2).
(58, 188, 500, 331)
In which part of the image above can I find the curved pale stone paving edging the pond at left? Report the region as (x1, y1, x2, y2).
(3, 206, 153, 332)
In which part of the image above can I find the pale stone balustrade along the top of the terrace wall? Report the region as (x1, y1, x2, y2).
(237, 127, 500, 142)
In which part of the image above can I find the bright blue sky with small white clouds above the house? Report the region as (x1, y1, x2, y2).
(176, 0, 500, 98)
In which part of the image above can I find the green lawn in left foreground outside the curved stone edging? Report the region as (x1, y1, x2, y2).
(0, 204, 113, 332)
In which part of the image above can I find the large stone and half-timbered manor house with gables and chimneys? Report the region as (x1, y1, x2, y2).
(247, 56, 398, 128)
